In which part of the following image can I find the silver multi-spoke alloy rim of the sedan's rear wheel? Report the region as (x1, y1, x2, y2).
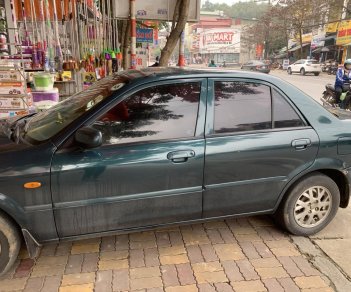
(294, 186, 332, 228)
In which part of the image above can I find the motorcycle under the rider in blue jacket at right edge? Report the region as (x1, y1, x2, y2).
(321, 82, 351, 110)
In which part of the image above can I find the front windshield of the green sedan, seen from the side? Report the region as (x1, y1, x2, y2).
(24, 74, 128, 142)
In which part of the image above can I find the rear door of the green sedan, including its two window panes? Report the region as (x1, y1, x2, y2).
(203, 79, 319, 217)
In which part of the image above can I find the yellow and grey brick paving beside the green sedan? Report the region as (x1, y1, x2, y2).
(0, 216, 334, 292)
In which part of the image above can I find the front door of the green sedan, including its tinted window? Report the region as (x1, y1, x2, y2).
(52, 79, 207, 237)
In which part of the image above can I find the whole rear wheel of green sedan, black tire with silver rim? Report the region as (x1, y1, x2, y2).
(275, 173, 340, 236)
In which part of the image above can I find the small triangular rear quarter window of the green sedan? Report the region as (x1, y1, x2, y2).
(272, 89, 305, 128)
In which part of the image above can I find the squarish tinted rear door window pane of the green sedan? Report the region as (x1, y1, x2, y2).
(214, 82, 272, 133)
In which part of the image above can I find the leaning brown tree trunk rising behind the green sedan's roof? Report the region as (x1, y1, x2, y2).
(160, 0, 190, 66)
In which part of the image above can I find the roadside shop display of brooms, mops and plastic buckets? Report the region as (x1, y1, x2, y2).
(0, 0, 122, 117)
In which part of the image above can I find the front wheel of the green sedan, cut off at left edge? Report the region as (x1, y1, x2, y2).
(0, 213, 21, 276)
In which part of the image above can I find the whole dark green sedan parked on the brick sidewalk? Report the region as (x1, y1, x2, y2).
(0, 68, 351, 273)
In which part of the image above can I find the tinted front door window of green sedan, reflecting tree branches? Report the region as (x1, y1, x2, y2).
(93, 82, 201, 145)
